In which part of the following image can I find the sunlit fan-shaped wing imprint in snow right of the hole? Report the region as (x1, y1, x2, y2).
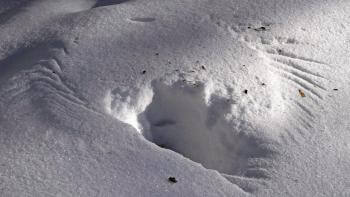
(243, 34, 330, 144)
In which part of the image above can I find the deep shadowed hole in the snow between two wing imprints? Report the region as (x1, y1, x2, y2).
(105, 76, 277, 192)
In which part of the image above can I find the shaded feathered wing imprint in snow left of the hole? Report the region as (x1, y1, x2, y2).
(0, 43, 102, 117)
